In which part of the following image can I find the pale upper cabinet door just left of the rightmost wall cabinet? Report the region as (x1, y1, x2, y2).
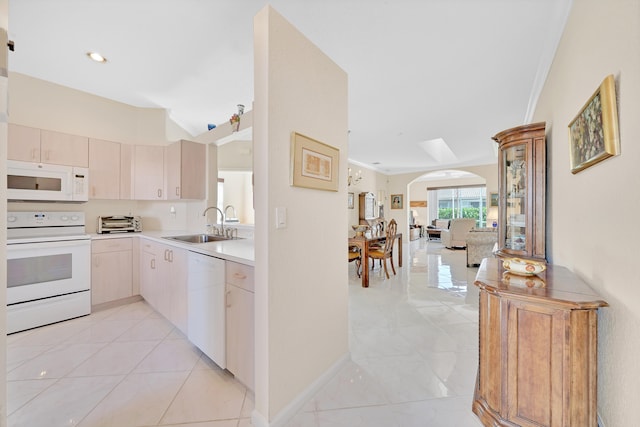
(133, 145, 165, 200)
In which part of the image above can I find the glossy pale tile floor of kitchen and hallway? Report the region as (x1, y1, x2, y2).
(7, 239, 481, 427)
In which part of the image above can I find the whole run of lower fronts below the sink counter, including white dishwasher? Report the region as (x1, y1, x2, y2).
(140, 239, 254, 390)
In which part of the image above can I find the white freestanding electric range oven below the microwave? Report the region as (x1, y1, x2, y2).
(7, 212, 91, 333)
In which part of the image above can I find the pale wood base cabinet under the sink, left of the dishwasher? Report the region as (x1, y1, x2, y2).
(140, 240, 188, 334)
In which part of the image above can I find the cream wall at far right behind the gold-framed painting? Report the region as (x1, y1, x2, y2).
(534, 0, 640, 427)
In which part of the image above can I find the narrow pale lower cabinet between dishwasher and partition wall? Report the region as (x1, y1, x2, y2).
(226, 261, 254, 390)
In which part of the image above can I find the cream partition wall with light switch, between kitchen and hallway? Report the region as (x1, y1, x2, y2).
(253, 6, 349, 425)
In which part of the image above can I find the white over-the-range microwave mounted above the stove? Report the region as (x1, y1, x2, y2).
(7, 160, 89, 202)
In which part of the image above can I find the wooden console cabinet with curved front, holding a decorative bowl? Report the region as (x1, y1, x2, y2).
(473, 258, 608, 427)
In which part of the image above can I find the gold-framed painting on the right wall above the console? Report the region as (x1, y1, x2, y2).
(569, 75, 620, 174)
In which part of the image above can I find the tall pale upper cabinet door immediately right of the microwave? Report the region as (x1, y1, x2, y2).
(89, 139, 121, 200)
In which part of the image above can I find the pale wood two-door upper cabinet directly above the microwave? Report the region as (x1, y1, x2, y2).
(7, 123, 89, 168)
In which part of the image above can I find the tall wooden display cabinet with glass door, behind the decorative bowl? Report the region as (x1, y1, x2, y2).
(493, 123, 546, 261)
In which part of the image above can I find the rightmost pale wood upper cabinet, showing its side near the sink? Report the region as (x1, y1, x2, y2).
(164, 140, 206, 200)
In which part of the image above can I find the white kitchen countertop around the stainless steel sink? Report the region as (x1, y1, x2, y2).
(91, 230, 255, 267)
